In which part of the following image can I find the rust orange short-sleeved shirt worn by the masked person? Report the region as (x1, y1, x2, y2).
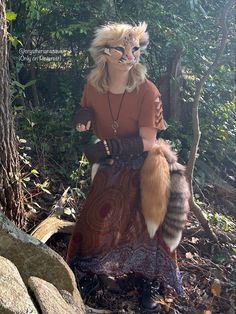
(81, 79, 165, 139)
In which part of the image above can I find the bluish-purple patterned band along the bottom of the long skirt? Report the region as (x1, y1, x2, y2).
(73, 246, 183, 295)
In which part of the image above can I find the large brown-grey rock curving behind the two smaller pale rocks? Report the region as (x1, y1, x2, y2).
(0, 211, 85, 313)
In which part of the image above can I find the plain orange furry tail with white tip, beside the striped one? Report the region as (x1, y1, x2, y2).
(140, 146, 170, 238)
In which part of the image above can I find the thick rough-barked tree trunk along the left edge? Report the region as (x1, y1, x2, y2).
(0, 0, 24, 227)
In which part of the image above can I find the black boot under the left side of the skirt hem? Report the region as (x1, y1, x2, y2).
(79, 274, 100, 301)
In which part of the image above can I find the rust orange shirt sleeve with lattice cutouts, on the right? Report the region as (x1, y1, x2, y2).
(138, 81, 165, 130)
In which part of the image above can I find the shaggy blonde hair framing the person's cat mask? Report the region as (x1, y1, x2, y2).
(88, 22, 149, 93)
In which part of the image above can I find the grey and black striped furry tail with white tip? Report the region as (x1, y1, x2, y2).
(162, 162, 190, 252)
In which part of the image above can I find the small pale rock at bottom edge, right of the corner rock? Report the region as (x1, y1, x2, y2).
(28, 277, 76, 314)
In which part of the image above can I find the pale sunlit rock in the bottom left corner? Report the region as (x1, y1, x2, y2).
(0, 256, 38, 314)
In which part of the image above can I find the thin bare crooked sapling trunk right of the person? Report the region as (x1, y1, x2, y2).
(186, 0, 234, 241)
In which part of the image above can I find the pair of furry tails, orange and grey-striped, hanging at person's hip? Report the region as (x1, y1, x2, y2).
(141, 140, 190, 251)
